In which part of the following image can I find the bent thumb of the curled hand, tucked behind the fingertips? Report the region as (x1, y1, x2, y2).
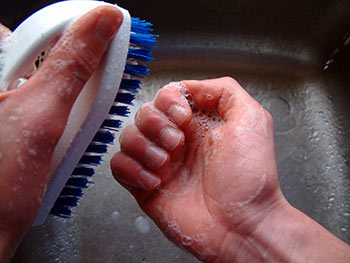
(182, 77, 261, 121)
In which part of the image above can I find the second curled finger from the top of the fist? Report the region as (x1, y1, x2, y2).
(135, 103, 185, 151)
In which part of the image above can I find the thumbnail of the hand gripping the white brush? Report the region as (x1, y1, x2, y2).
(96, 7, 123, 41)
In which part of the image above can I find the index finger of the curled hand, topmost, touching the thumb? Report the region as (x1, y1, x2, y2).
(154, 82, 192, 128)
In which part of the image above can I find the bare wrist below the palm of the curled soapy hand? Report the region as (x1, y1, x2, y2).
(214, 194, 350, 263)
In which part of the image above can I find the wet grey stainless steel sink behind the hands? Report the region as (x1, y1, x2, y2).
(8, 0, 350, 263)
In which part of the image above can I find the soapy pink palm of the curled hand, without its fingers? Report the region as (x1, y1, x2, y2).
(136, 103, 277, 262)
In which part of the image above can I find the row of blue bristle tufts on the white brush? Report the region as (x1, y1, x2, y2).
(50, 17, 158, 218)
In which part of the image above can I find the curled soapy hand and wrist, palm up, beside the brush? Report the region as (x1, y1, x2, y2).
(111, 78, 350, 263)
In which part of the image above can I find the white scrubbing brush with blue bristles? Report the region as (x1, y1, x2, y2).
(2, 0, 156, 225)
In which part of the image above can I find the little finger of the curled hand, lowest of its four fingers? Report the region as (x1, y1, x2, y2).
(111, 152, 161, 191)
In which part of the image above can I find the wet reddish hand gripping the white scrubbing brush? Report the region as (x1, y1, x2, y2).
(0, 6, 122, 262)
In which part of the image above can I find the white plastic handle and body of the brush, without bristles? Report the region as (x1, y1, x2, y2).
(2, 0, 131, 225)
